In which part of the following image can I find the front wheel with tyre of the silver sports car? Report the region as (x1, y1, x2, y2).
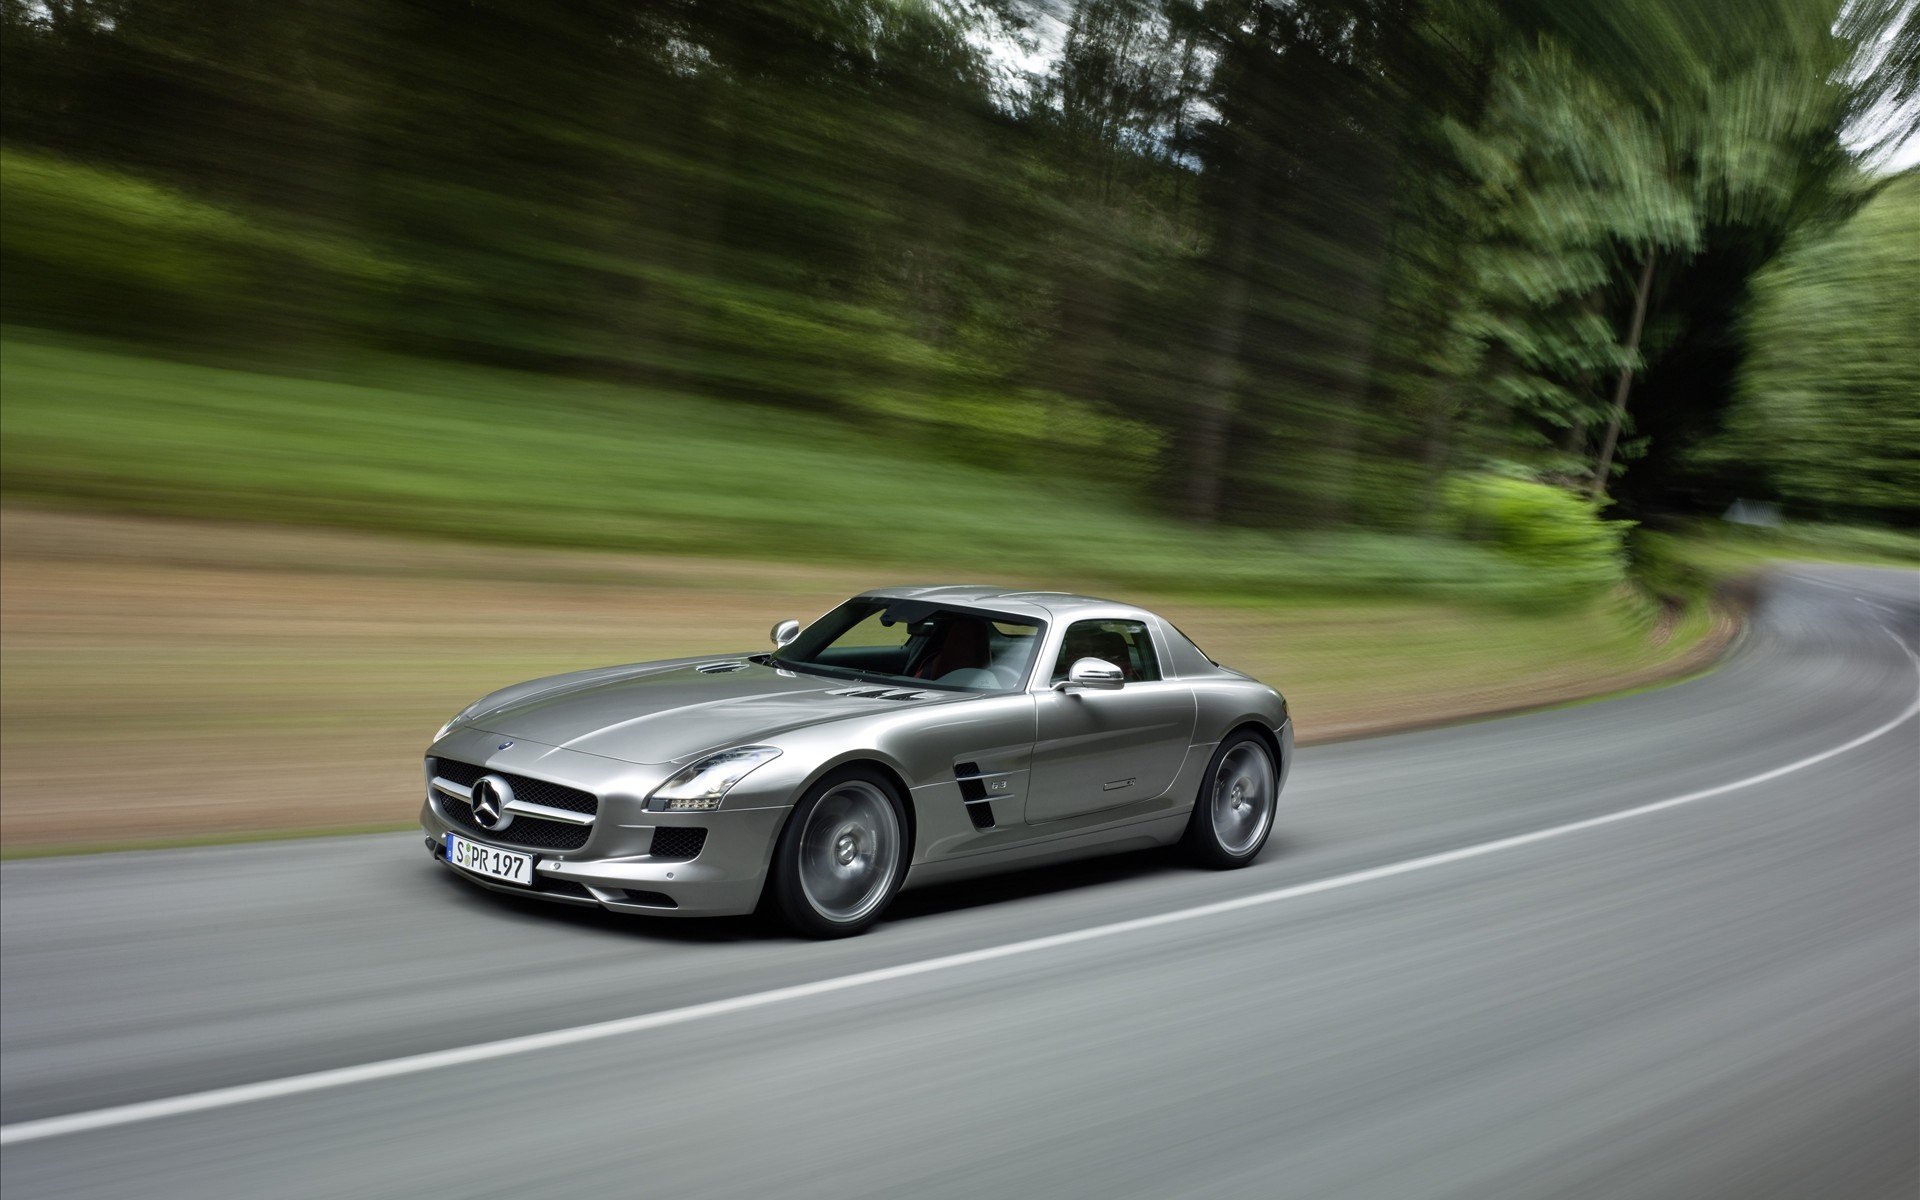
(766, 766, 910, 937)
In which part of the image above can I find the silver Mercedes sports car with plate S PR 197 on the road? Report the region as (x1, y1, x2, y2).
(420, 588, 1294, 937)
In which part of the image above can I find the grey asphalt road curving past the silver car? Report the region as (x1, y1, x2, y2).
(0, 568, 1920, 1200)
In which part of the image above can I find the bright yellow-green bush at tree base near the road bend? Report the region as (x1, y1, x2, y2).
(1446, 474, 1632, 593)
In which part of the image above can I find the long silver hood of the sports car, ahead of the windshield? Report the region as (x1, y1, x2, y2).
(461, 659, 973, 762)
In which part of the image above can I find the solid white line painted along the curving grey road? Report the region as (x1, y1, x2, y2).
(0, 626, 1920, 1146)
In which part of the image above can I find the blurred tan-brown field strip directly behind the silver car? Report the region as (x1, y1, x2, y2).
(0, 505, 1728, 854)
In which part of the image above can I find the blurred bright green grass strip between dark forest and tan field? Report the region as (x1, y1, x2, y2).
(0, 330, 1605, 605)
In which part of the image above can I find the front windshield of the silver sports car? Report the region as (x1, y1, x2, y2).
(774, 597, 1046, 691)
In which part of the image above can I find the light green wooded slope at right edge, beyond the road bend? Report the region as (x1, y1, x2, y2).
(1701, 171, 1920, 524)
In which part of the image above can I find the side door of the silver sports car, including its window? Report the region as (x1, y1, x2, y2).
(1027, 618, 1194, 824)
